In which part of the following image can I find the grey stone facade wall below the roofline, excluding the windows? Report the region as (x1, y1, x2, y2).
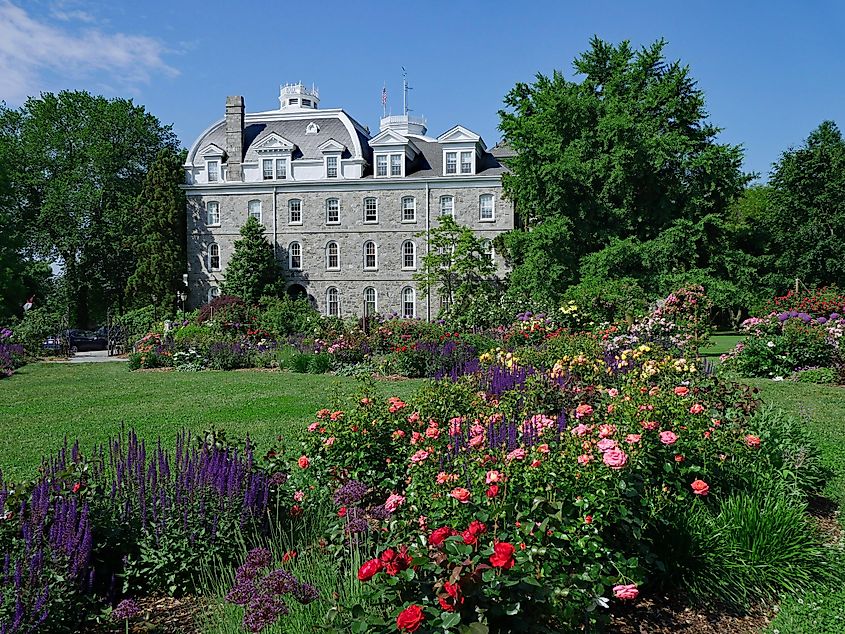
(188, 179, 513, 319)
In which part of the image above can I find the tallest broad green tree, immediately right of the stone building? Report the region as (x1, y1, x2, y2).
(500, 38, 750, 302)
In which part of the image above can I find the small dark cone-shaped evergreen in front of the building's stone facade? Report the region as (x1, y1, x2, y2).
(222, 216, 283, 304)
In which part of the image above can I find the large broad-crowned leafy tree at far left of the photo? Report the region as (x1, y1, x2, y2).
(2, 91, 178, 325)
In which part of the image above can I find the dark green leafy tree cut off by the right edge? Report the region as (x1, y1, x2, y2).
(768, 121, 845, 291)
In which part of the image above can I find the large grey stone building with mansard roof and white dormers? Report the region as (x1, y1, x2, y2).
(185, 84, 514, 319)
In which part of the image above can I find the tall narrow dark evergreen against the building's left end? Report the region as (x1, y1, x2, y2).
(126, 148, 187, 311)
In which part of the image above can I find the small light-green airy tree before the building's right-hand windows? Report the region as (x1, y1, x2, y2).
(414, 216, 498, 326)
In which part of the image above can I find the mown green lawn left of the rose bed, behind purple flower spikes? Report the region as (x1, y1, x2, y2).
(0, 363, 420, 479)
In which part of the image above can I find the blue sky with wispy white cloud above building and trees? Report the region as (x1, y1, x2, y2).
(0, 0, 845, 177)
